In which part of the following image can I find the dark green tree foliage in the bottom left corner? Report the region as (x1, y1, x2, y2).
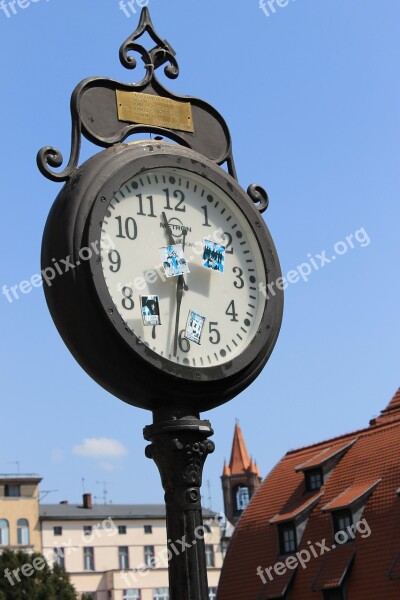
(0, 550, 78, 600)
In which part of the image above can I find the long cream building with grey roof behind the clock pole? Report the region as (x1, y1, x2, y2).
(40, 494, 222, 600)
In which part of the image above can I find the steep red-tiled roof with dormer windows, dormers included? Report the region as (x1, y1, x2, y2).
(218, 389, 400, 600)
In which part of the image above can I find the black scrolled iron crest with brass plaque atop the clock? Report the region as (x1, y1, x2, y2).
(37, 7, 268, 212)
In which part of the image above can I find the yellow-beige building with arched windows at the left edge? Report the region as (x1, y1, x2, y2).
(0, 475, 42, 553)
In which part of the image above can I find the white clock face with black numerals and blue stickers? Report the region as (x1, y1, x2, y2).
(96, 167, 266, 369)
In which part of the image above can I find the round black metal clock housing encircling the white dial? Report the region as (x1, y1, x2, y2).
(42, 141, 283, 415)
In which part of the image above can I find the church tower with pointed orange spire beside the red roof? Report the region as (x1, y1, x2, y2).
(221, 423, 261, 525)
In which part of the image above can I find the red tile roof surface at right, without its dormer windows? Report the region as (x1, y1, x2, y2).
(218, 390, 400, 600)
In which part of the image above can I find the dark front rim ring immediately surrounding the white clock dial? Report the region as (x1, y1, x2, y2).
(87, 142, 281, 382)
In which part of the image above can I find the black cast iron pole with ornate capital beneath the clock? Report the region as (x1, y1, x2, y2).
(144, 415, 215, 600)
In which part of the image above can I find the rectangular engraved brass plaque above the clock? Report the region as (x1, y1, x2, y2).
(116, 90, 194, 133)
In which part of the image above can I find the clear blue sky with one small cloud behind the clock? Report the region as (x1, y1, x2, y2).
(0, 0, 400, 509)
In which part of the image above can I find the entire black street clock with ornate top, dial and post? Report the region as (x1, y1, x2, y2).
(37, 8, 283, 600)
